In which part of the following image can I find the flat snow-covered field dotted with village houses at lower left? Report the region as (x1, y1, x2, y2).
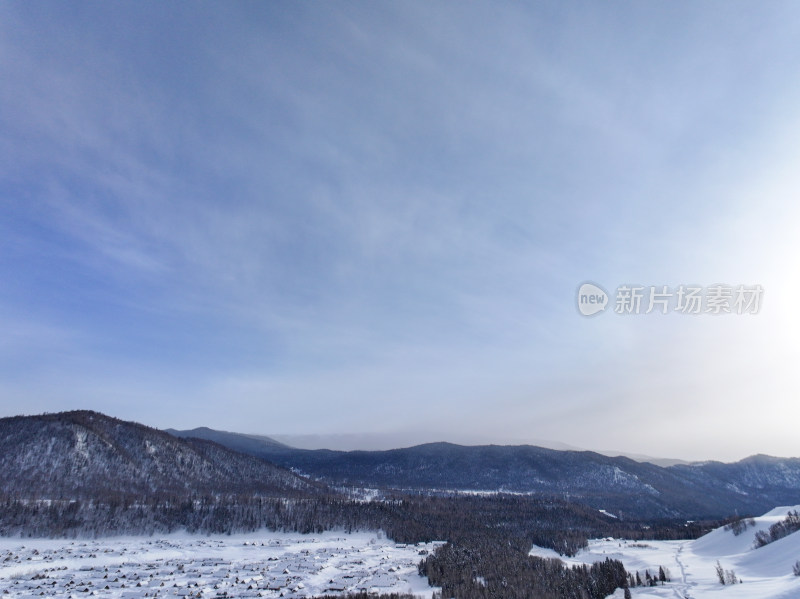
(0, 532, 444, 599)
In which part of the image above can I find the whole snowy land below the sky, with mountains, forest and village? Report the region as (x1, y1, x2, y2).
(0, 411, 800, 599)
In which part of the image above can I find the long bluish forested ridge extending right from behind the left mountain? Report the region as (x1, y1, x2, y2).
(169, 429, 800, 518)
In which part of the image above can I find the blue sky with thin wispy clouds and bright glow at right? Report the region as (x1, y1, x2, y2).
(0, 0, 800, 461)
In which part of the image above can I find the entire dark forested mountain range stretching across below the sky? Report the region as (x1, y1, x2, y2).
(0, 411, 800, 519)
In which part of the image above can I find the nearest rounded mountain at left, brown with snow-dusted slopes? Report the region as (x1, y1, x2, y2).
(0, 411, 315, 499)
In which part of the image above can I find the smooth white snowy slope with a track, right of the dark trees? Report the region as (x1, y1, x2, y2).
(531, 506, 800, 599)
